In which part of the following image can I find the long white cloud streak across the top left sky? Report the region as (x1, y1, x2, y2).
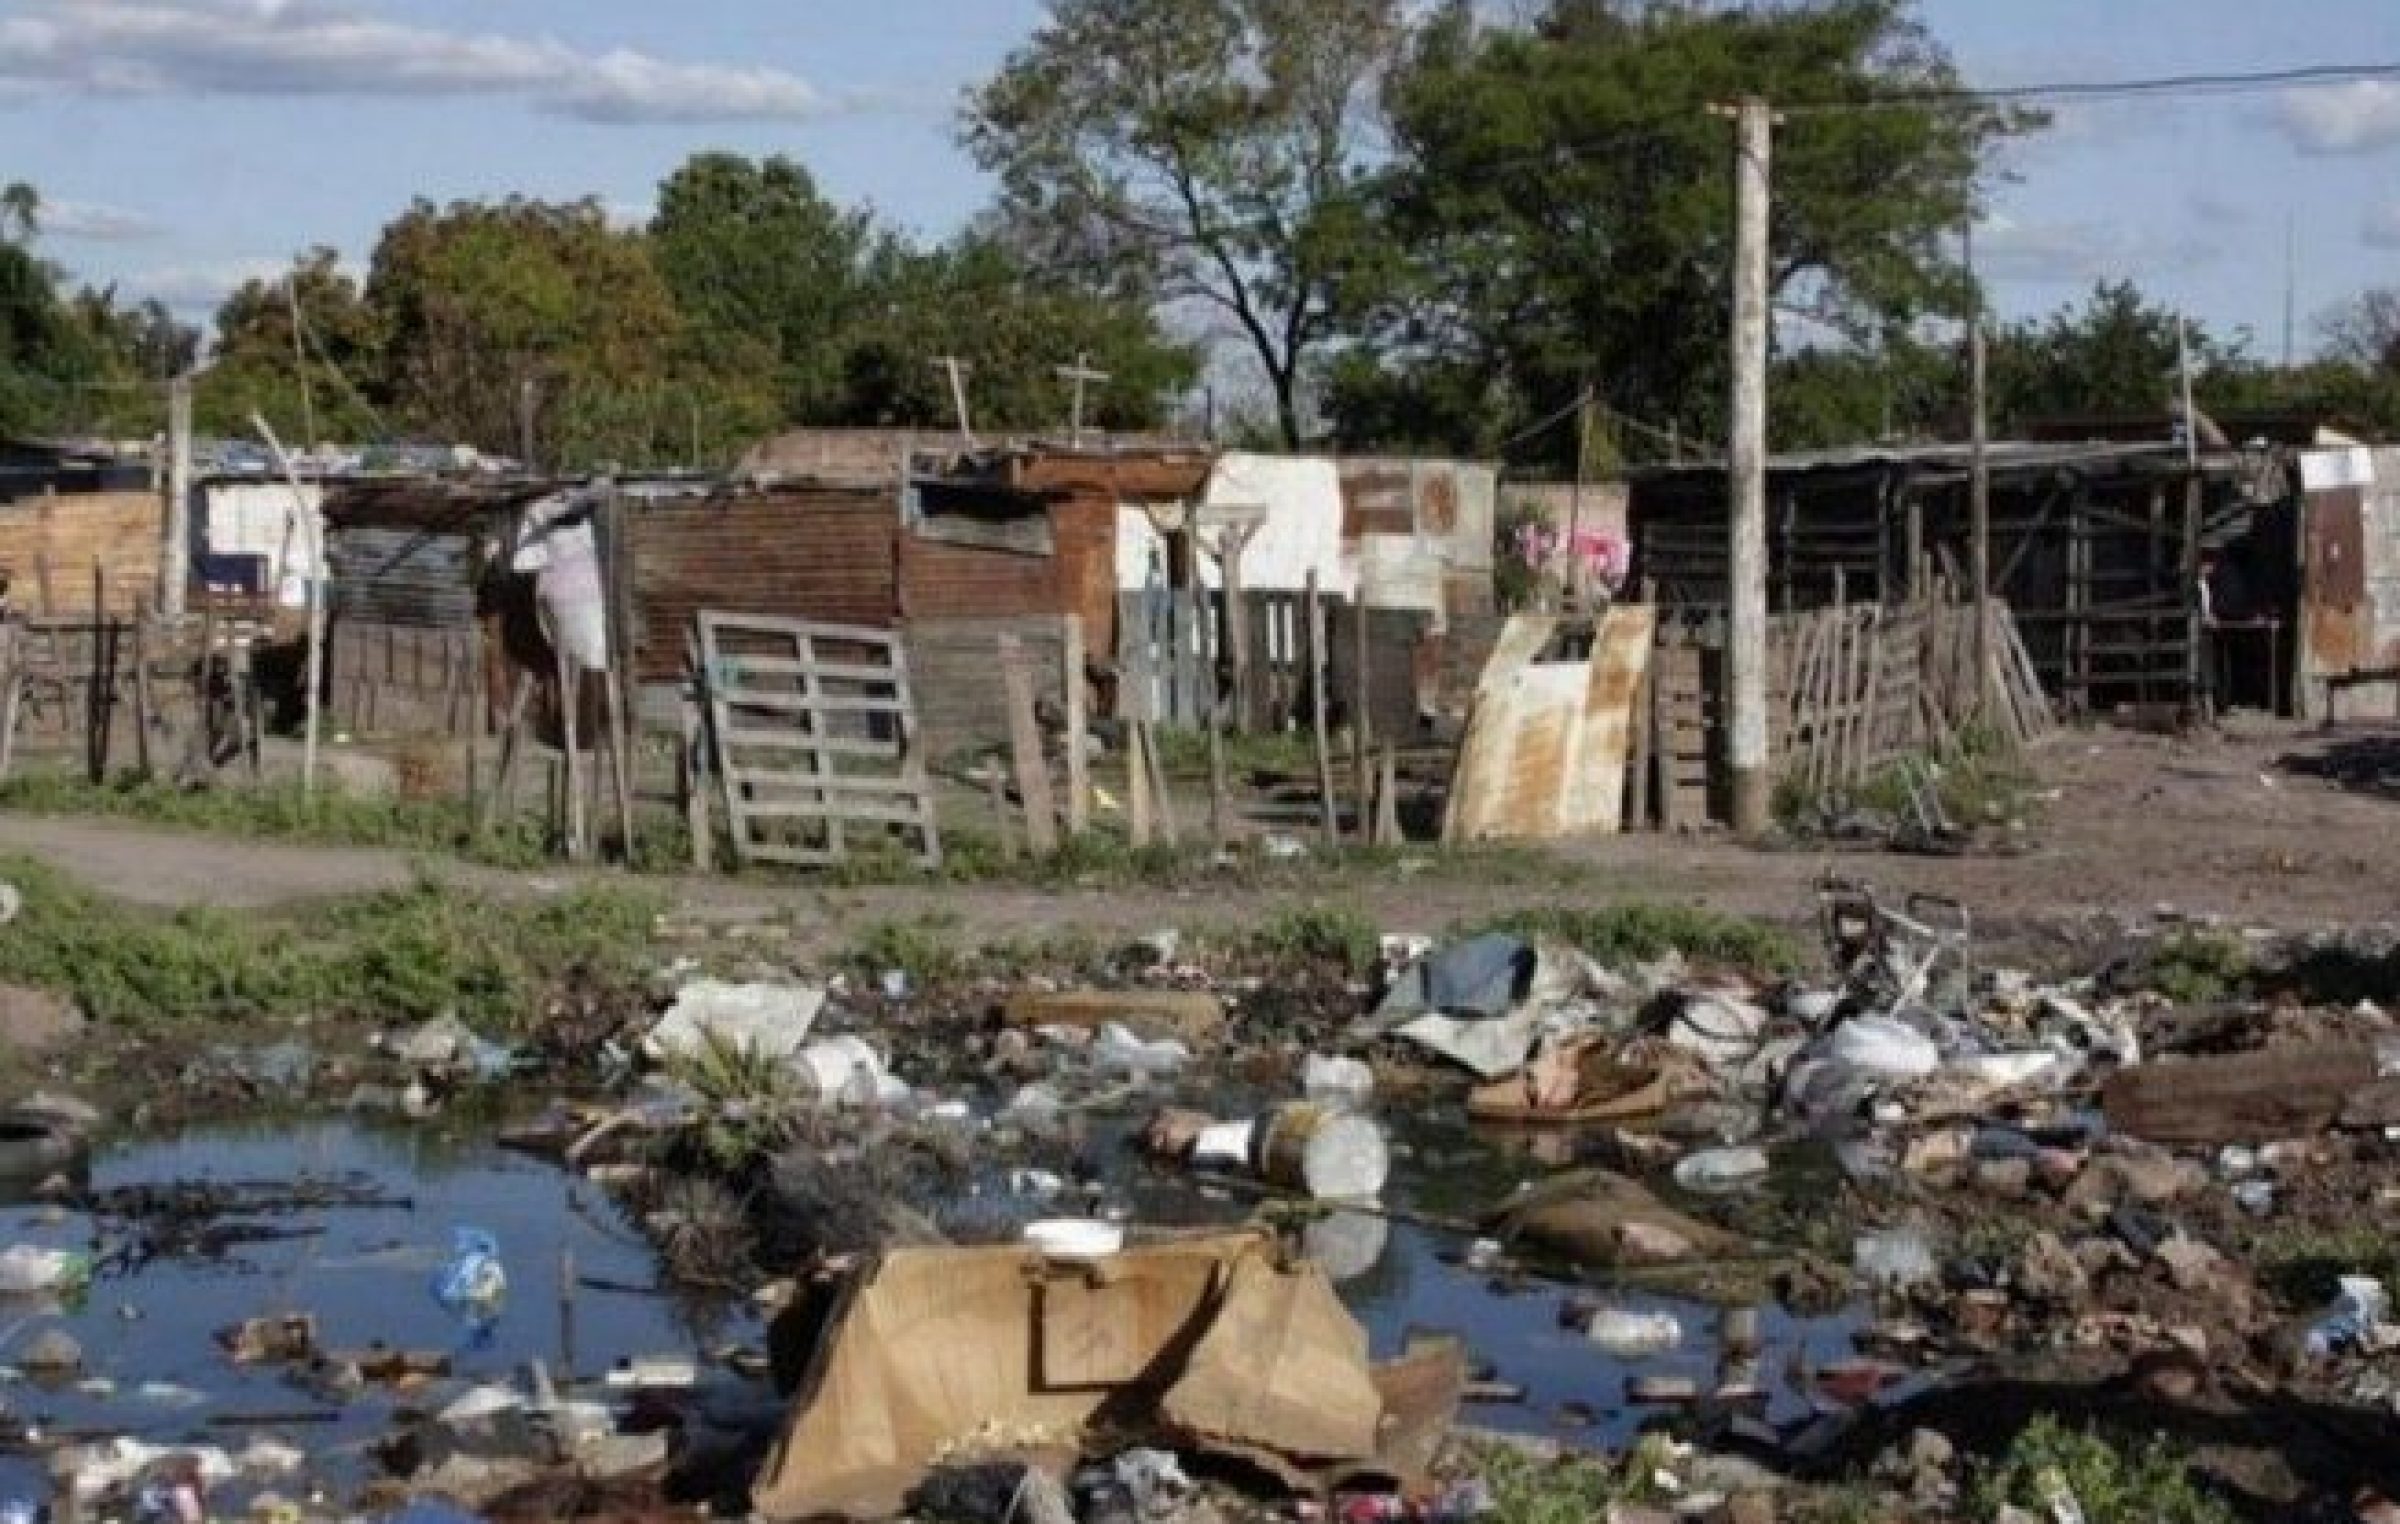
(0, 0, 840, 125)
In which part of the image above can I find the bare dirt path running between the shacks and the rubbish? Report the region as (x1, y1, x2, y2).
(0, 725, 2400, 941)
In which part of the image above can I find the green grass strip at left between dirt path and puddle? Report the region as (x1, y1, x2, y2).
(0, 859, 658, 1032)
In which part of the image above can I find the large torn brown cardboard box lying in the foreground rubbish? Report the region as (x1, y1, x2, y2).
(751, 1234, 1464, 1519)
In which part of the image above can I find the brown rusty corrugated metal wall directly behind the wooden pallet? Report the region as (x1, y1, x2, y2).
(626, 490, 900, 682)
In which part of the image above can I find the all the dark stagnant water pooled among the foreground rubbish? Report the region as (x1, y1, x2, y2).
(0, 1118, 1860, 1500)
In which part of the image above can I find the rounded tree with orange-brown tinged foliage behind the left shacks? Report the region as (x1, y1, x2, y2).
(365, 197, 694, 468)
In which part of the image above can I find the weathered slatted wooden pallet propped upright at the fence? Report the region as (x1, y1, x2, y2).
(694, 610, 941, 866)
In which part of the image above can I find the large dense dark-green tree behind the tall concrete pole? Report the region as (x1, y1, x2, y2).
(1332, 0, 2035, 456)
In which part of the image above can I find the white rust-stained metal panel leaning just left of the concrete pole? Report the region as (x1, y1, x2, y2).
(1442, 605, 1656, 842)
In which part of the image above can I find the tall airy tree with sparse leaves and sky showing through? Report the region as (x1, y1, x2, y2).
(965, 0, 1402, 446)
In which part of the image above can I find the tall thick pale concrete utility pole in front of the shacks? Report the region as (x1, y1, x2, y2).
(1711, 96, 1776, 835)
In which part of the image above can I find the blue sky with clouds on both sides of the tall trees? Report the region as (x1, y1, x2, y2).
(0, 0, 2400, 355)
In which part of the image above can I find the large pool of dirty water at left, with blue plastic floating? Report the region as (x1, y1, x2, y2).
(0, 1121, 756, 1498)
